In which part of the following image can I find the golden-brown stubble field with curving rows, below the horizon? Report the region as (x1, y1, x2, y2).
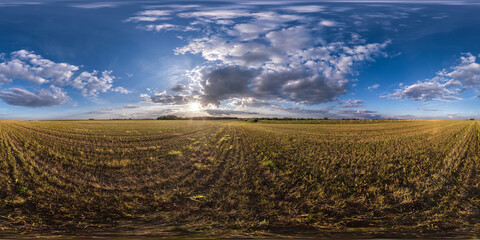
(0, 120, 480, 235)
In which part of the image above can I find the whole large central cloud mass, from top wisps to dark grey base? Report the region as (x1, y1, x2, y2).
(130, 5, 390, 111)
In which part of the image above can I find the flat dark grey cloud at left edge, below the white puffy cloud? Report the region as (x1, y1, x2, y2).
(0, 85, 70, 108)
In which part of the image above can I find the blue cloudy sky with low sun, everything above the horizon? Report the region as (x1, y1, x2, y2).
(0, 0, 480, 120)
